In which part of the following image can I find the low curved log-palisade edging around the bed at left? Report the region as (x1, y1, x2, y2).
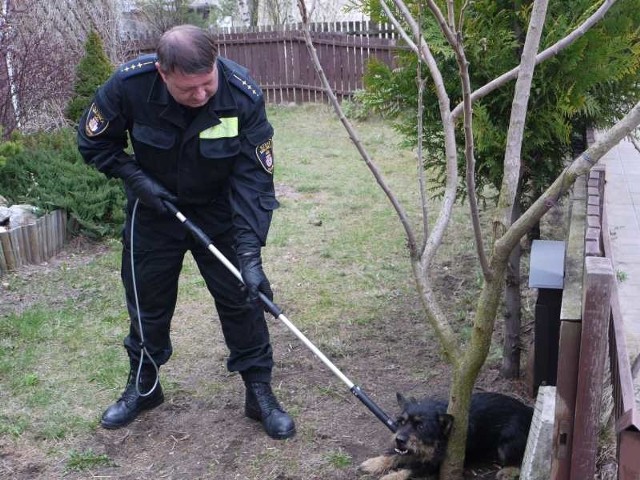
(0, 210, 67, 274)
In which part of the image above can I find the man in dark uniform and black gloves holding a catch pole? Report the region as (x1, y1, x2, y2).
(78, 25, 295, 439)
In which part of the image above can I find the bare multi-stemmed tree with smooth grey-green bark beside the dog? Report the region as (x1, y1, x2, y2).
(298, 0, 640, 480)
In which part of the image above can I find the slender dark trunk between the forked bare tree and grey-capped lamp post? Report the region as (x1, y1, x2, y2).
(501, 202, 522, 378)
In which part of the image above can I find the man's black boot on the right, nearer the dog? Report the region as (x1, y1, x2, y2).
(244, 382, 296, 440)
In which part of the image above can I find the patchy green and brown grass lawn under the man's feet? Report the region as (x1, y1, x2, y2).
(0, 105, 528, 480)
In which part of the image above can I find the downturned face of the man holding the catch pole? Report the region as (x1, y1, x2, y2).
(156, 63, 218, 108)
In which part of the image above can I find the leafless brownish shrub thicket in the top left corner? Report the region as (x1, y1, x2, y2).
(0, 0, 122, 133)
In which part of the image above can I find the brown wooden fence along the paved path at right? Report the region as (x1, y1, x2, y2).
(551, 160, 640, 480)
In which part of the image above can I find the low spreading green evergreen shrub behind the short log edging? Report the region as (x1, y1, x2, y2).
(0, 129, 125, 238)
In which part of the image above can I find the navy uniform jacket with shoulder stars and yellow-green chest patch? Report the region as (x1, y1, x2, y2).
(78, 55, 278, 250)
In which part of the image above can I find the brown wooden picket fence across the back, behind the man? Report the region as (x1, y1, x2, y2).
(129, 22, 399, 103)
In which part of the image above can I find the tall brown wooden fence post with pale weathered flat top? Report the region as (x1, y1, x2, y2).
(570, 257, 614, 480)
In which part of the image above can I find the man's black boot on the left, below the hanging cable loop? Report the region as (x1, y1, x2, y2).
(100, 366, 164, 429)
